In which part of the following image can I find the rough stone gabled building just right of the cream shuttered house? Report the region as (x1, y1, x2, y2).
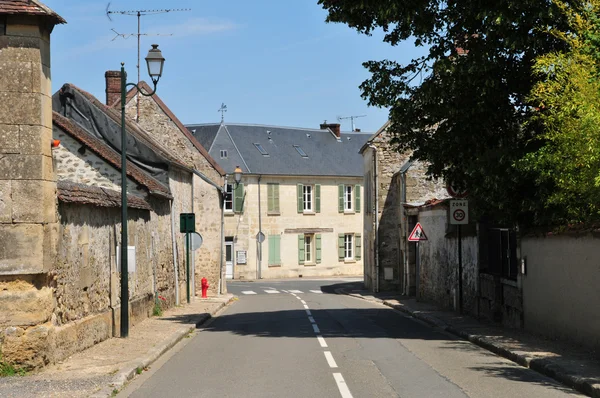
(360, 122, 447, 294)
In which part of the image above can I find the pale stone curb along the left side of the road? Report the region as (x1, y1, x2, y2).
(90, 296, 236, 398)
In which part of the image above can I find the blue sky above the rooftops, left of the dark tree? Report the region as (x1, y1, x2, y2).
(44, 0, 423, 132)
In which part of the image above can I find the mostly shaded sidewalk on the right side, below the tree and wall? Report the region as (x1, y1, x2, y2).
(339, 289, 600, 398)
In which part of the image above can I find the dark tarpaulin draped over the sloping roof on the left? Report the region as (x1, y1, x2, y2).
(52, 85, 169, 186)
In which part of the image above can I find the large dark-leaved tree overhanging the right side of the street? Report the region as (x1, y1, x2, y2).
(319, 0, 568, 225)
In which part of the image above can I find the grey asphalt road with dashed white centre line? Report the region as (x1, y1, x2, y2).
(119, 280, 578, 398)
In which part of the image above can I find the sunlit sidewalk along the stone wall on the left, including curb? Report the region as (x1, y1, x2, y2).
(0, 294, 234, 398)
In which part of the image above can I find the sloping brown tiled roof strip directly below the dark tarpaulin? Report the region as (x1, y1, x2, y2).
(52, 112, 171, 198)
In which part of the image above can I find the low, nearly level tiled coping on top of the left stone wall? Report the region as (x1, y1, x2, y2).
(57, 181, 152, 210)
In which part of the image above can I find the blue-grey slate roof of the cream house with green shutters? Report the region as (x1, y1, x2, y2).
(186, 123, 370, 177)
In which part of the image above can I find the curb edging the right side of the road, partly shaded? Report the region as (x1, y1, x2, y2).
(336, 289, 600, 398)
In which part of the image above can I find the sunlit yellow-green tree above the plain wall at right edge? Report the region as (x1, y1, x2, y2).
(518, 0, 600, 224)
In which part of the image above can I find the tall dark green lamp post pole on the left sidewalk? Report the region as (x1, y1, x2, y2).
(121, 63, 129, 338)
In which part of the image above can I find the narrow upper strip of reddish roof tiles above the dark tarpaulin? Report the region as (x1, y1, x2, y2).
(61, 83, 192, 170)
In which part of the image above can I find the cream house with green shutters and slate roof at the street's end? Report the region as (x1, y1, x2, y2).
(187, 123, 368, 279)
